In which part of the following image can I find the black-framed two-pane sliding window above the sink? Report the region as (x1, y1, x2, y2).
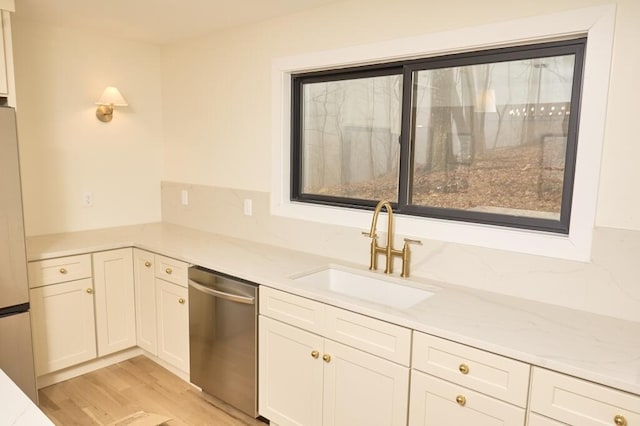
(291, 38, 586, 234)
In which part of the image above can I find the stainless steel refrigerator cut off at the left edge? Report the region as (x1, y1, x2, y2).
(0, 107, 37, 403)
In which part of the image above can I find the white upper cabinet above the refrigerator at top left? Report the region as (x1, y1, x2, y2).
(0, 0, 16, 107)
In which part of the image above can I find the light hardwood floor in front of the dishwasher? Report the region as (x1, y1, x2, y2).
(39, 356, 265, 426)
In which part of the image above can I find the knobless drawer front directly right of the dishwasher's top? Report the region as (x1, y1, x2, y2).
(258, 286, 325, 334)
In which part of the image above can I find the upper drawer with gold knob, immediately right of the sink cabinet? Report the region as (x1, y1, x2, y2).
(413, 332, 530, 407)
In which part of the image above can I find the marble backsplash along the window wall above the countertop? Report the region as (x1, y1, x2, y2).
(162, 182, 640, 322)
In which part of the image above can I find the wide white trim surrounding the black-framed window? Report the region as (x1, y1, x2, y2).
(270, 4, 616, 262)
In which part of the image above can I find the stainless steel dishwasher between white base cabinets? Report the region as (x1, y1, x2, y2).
(189, 266, 258, 418)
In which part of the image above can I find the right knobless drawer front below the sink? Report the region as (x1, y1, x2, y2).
(325, 306, 411, 367)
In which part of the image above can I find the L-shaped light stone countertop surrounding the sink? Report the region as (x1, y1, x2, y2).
(27, 223, 640, 395)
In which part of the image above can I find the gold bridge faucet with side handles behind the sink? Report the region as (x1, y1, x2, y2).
(362, 200, 422, 278)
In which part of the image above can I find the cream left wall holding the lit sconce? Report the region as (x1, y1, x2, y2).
(12, 19, 163, 235)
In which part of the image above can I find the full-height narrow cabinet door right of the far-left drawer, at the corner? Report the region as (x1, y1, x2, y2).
(93, 248, 136, 356)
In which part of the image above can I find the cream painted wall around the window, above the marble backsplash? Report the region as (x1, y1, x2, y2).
(163, 0, 640, 230)
